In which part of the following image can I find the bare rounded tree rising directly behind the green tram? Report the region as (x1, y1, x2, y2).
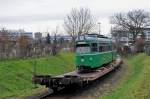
(64, 8, 95, 42)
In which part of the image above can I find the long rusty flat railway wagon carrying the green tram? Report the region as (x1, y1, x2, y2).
(33, 58, 122, 91)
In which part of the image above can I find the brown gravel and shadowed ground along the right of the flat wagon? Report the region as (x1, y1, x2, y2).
(45, 64, 127, 99)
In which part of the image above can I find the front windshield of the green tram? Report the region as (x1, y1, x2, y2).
(76, 44, 90, 54)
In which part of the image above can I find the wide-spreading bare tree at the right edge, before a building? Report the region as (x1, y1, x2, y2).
(111, 10, 150, 43)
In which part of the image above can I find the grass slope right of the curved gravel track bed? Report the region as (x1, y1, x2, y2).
(100, 53, 150, 99)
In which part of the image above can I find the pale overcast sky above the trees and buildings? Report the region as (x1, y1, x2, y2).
(0, 0, 150, 35)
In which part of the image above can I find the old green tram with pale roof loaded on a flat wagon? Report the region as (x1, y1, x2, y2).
(76, 34, 116, 70)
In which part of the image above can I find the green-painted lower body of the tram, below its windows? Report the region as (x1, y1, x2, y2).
(76, 51, 116, 68)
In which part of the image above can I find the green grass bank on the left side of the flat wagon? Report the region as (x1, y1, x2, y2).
(0, 53, 75, 99)
